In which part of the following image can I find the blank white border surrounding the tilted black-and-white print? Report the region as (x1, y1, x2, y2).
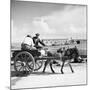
(0, 0, 90, 90)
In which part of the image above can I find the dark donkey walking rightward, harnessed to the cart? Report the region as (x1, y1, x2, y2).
(43, 47, 79, 74)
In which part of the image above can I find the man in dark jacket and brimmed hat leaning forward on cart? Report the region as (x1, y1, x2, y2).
(33, 33, 45, 49)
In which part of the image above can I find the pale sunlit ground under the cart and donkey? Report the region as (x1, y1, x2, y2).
(11, 63, 87, 89)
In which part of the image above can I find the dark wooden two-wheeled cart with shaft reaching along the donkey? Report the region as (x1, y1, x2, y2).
(12, 50, 60, 74)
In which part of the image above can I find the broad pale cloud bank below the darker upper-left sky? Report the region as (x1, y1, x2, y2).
(11, 6, 86, 41)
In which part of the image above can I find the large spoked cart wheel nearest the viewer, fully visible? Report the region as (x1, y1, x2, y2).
(14, 51, 35, 74)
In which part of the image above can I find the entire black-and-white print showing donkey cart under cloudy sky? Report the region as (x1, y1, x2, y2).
(10, 0, 87, 90)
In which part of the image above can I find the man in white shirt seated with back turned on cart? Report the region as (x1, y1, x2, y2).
(21, 35, 35, 50)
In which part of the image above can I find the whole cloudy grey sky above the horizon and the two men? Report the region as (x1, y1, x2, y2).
(11, 0, 87, 42)
